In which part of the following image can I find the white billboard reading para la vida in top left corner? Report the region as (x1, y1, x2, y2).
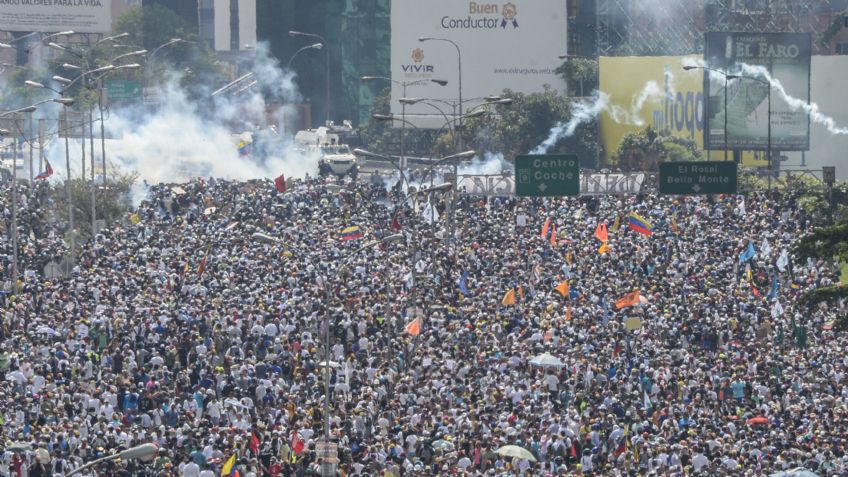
(0, 0, 112, 33)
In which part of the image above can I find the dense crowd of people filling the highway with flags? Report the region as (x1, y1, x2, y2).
(0, 173, 848, 477)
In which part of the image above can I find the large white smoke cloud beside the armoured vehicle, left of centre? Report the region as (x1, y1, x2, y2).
(39, 44, 318, 194)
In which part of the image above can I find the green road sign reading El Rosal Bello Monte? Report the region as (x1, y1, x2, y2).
(660, 161, 736, 195)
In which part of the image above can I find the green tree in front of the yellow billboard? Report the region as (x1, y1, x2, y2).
(614, 126, 703, 171)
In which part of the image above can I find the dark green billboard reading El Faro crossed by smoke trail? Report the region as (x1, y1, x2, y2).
(704, 32, 811, 151)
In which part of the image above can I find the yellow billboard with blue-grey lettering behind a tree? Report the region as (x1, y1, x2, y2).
(599, 55, 767, 166)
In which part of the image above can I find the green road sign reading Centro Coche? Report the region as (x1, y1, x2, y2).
(515, 154, 580, 197)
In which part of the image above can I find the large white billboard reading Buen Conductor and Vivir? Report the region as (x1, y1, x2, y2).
(391, 0, 567, 128)
